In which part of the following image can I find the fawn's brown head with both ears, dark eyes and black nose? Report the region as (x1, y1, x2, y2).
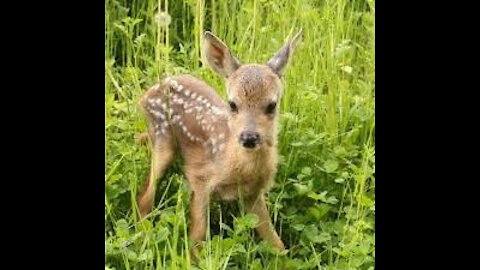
(205, 30, 302, 151)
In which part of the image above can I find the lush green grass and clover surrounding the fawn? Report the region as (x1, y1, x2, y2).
(105, 0, 375, 270)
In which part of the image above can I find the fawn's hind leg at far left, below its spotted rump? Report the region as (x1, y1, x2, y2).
(138, 132, 175, 218)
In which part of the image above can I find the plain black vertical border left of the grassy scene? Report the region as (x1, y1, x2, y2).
(1, 1, 105, 269)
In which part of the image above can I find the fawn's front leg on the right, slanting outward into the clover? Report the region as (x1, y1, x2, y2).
(245, 194, 285, 251)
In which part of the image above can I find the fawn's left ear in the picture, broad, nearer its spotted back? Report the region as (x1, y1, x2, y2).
(205, 31, 241, 78)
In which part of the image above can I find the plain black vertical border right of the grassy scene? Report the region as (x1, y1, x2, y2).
(375, 1, 478, 269)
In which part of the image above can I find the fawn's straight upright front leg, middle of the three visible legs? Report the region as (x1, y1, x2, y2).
(190, 187, 209, 259)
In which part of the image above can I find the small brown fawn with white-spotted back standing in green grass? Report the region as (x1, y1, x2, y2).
(138, 30, 302, 255)
